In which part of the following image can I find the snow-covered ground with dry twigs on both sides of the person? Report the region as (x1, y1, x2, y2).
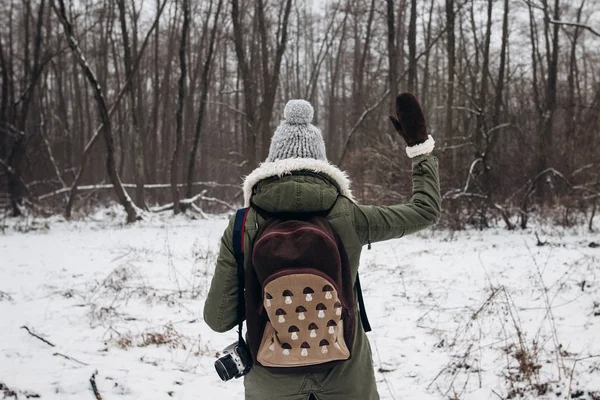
(0, 213, 600, 400)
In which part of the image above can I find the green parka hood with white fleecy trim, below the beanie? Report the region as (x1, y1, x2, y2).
(243, 158, 354, 212)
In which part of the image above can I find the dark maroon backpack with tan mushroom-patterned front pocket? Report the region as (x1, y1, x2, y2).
(233, 208, 371, 373)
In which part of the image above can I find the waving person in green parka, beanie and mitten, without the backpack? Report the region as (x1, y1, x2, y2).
(204, 93, 441, 400)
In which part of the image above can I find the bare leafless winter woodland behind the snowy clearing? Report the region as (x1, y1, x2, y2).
(0, 0, 600, 230)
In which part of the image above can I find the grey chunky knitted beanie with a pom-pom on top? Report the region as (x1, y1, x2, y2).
(267, 100, 327, 162)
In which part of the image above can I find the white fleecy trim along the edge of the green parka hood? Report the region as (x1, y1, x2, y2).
(243, 158, 354, 207)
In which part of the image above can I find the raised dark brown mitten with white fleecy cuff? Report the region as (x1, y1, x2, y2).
(390, 93, 435, 158)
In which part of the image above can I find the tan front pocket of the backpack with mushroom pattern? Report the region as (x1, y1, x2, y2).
(257, 270, 350, 367)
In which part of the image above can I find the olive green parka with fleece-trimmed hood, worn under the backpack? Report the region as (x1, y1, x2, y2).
(204, 156, 441, 400)
